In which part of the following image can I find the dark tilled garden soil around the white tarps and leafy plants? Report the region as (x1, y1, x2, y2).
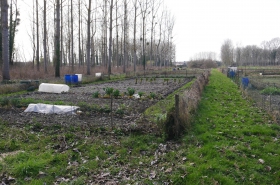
(0, 78, 190, 131)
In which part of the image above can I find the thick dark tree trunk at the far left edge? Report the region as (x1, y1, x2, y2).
(1, 0, 10, 80)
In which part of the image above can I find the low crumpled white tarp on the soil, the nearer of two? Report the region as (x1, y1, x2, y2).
(24, 103, 79, 114)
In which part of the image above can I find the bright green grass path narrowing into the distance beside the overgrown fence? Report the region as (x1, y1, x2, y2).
(173, 70, 280, 184)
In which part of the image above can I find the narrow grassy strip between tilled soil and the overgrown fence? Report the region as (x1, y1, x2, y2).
(144, 79, 196, 123)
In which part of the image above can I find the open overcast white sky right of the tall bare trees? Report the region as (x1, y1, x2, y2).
(165, 0, 280, 61)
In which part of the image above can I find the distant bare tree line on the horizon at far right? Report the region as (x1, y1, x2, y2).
(221, 37, 280, 66)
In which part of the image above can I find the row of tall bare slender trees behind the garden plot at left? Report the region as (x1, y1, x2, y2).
(0, 0, 176, 80)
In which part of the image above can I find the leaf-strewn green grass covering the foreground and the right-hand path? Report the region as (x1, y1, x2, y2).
(0, 71, 280, 184)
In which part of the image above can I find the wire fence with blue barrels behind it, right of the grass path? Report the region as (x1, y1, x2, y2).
(221, 69, 280, 123)
